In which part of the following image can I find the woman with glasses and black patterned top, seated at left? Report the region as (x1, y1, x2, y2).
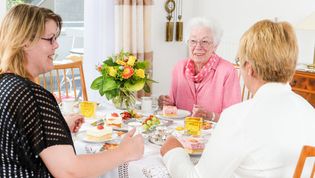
(0, 4, 144, 177)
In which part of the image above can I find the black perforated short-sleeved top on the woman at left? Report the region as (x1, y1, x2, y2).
(0, 74, 73, 177)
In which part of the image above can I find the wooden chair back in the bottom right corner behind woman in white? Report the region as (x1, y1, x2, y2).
(293, 145, 315, 178)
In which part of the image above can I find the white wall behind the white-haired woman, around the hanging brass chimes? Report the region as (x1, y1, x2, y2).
(152, 0, 315, 95)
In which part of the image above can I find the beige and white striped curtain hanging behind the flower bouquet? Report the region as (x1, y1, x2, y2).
(115, 0, 153, 97)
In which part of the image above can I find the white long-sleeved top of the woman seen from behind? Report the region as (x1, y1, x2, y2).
(163, 83, 315, 178)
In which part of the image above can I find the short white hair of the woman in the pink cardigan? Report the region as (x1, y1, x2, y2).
(184, 17, 223, 46)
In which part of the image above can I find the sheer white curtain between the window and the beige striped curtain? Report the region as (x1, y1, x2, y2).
(83, 0, 115, 103)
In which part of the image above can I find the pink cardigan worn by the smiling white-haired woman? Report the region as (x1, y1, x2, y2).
(169, 58, 241, 114)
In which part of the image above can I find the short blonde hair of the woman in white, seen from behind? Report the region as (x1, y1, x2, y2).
(238, 20, 298, 83)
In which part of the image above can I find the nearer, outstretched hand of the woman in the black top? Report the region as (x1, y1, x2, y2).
(118, 128, 144, 161)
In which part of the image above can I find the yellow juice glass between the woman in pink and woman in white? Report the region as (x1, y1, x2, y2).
(185, 117, 203, 136)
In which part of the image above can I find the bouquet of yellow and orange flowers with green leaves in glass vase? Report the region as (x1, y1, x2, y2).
(91, 51, 154, 109)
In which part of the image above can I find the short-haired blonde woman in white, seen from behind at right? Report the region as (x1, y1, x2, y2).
(161, 20, 315, 178)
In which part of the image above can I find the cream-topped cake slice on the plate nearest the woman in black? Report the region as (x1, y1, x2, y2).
(85, 125, 113, 142)
